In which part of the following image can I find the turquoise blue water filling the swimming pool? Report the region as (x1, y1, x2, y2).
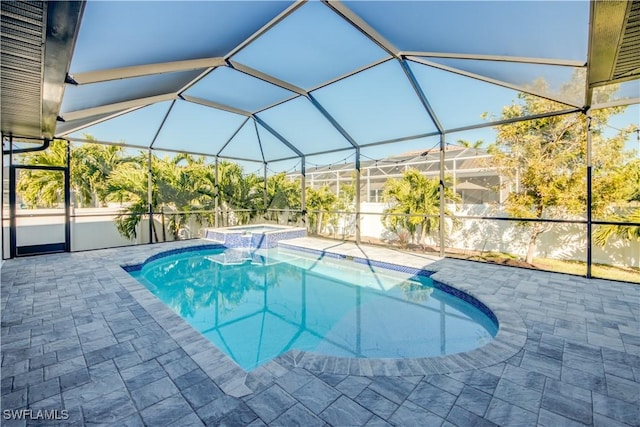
(131, 249, 497, 370)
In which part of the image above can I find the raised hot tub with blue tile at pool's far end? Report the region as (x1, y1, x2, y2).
(204, 224, 307, 249)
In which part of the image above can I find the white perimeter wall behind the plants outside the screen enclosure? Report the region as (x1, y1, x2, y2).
(7, 203, 640, 267)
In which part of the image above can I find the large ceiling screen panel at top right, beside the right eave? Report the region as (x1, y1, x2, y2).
(345, 1, 589, 61)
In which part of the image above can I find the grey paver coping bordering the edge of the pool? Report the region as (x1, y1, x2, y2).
(114, 238, 527, 397)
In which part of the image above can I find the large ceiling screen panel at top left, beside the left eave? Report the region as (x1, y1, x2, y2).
(71, 1, 291, 74)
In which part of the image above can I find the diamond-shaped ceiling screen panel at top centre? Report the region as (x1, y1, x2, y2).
(232, 2, 388, 90)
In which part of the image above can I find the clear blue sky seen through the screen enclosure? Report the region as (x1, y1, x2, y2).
(61, 1, 640, 172)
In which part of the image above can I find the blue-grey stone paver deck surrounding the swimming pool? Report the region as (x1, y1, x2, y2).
(1, 238, 640, 426)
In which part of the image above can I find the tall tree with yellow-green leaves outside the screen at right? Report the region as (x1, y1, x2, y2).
(489, 75, 631, 263)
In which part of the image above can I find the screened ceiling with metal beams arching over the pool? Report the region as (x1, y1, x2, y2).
(2, 1, 640, 162)
